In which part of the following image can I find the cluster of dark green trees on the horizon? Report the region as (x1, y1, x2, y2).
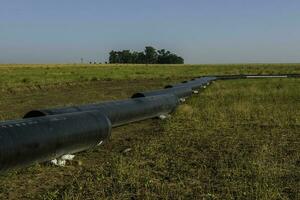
(109, 46, 184, 64)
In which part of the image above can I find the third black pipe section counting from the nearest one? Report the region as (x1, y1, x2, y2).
(131, 86, 193, 99)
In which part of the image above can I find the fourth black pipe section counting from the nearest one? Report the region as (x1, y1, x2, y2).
(165, 77, 217, 90)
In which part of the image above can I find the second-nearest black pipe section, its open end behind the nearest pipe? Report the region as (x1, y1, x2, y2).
(24, 94, 179, 127)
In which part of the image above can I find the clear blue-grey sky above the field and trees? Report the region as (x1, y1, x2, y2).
(0, 0, 300, 63)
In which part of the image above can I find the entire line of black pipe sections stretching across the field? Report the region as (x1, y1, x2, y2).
(0, 74, 300, 172)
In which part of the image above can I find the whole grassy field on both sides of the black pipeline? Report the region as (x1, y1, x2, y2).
(0, 64, 300, 199)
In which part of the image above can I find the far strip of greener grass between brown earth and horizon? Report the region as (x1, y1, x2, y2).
(0, 64, 300, 87)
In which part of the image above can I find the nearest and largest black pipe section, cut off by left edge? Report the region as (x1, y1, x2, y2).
(0, 111, 111, 171)
